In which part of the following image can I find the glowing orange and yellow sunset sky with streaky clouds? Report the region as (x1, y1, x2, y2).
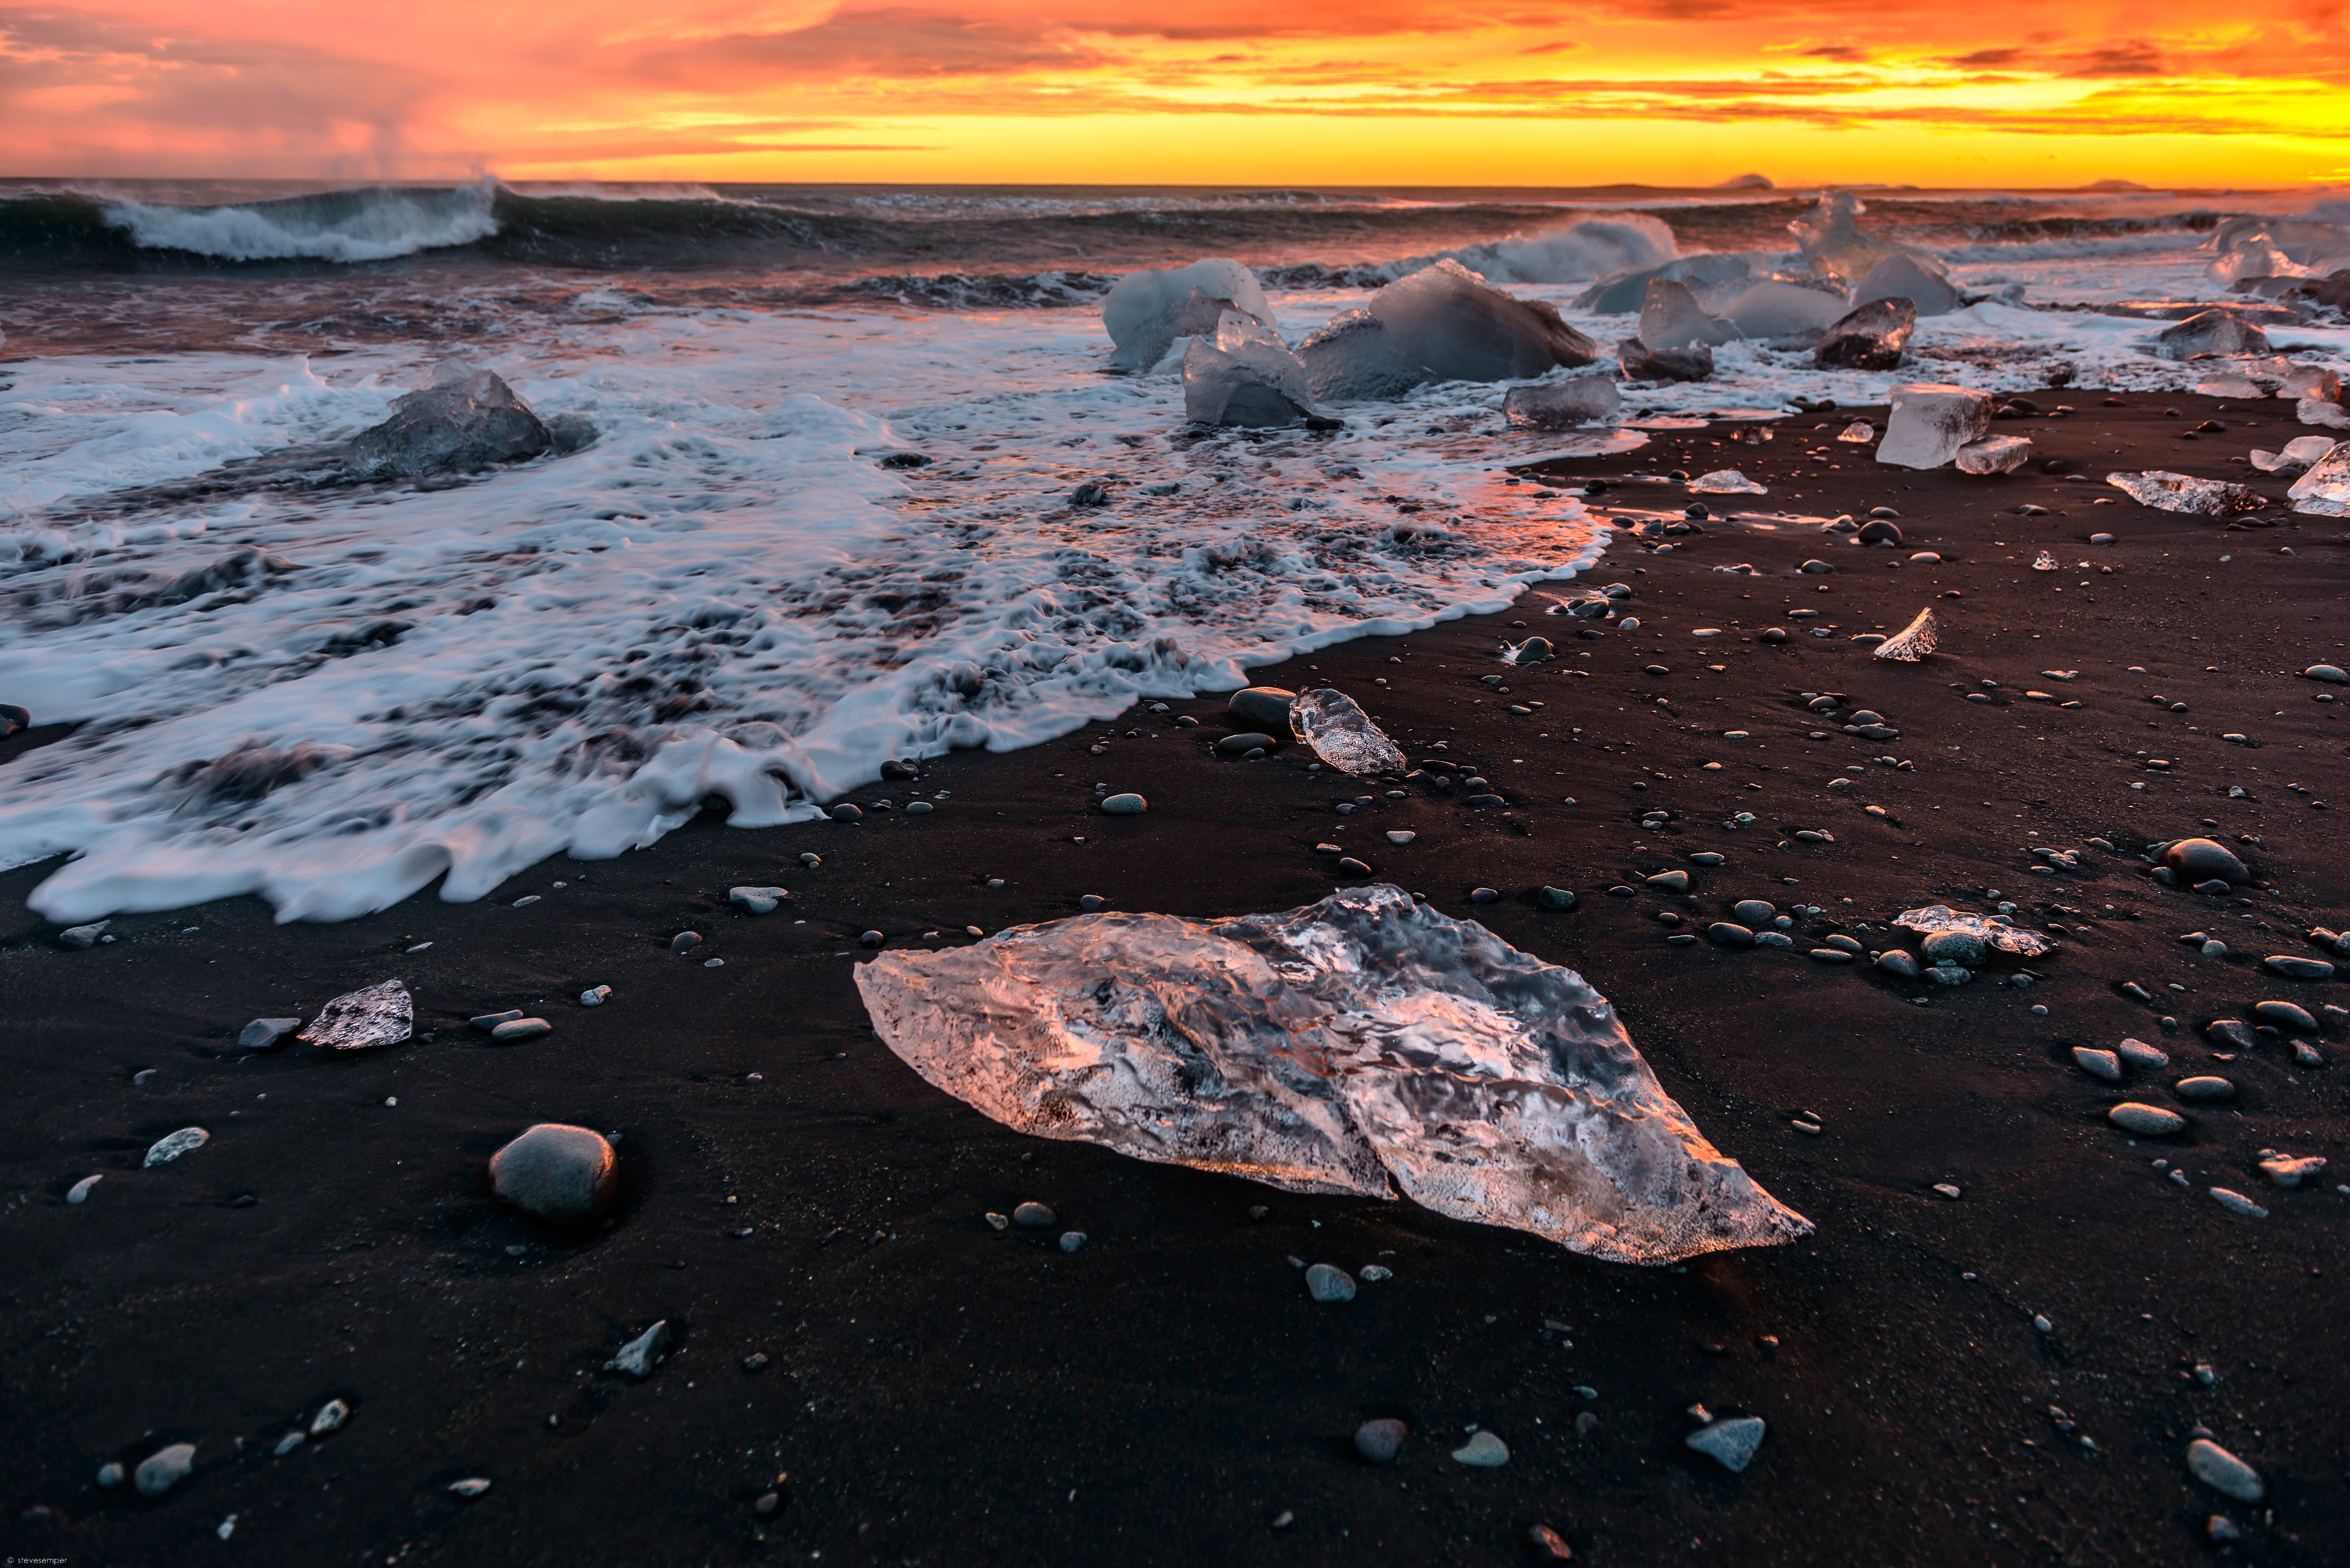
(0, 0, 2350, 186)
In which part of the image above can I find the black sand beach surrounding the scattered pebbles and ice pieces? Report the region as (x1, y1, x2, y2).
(0, 388, 2350, 1566)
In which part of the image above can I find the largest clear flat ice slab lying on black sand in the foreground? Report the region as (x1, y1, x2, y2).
(855, 884, 1812, 1265)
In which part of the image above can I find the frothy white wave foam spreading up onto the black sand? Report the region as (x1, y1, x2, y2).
(0, 301, 1603, 921)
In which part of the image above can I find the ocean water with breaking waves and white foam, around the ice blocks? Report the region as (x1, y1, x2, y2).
(0, 183, 2350, 921)
